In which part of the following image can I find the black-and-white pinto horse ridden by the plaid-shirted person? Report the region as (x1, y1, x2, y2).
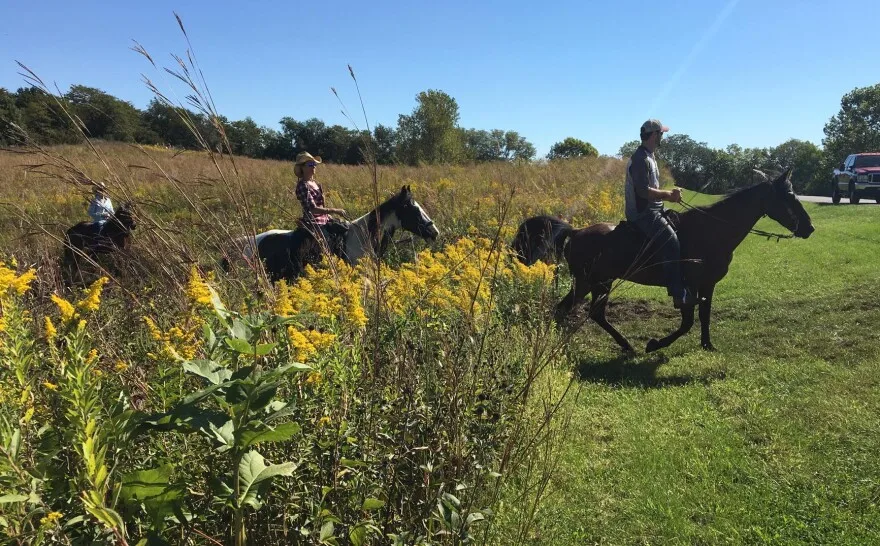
(230, 186, 440, 282)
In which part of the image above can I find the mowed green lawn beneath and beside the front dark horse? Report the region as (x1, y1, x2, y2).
(533, 196, 880, 545)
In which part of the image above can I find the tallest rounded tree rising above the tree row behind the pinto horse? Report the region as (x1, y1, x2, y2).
(397, 89, 465, 165)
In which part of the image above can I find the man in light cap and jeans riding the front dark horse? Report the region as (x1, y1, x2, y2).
(625, 119, 694, 309)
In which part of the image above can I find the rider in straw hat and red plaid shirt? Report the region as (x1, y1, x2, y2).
(293, 152, 348, 255)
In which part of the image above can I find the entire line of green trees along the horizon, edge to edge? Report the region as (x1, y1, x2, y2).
(0, 79, 880, 193)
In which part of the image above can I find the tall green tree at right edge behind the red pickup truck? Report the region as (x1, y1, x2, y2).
(822, 83, 880, 166)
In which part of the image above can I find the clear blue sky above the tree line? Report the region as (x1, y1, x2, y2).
(0, 0, 880, 154)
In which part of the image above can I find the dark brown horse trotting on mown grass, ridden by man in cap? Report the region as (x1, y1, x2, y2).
(556, 169, 814, 352)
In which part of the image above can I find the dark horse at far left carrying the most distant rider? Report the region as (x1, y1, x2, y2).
(61, 203, 136, 285)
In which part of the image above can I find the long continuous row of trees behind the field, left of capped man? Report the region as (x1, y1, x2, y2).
(0, 85, 548, 164)
